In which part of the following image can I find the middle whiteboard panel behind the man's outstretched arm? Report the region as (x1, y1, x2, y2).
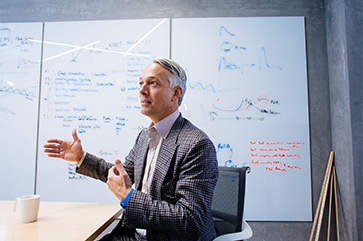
(37, 19, 170, 202)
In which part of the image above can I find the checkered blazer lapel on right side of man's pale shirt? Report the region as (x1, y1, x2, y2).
(150, 115, 184, 200)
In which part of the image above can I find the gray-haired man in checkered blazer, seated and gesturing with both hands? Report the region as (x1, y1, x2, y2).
(44, 58, 218, 241)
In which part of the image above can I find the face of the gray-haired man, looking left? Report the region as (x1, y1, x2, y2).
(139, 63, 181, 124)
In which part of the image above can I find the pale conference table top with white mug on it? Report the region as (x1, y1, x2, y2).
(0, 201, 121, 241)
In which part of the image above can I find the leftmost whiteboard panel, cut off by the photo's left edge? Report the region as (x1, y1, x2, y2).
(0, 23, 43, 200)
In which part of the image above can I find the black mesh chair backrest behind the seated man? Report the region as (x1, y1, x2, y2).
(212, 167, 250, 235)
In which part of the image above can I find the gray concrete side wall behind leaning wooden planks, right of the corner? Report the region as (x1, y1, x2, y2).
(326, 0, 363, 240)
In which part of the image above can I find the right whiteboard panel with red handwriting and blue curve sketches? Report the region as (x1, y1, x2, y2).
(171, 17, 312, 221)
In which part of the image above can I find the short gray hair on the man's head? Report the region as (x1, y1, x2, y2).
(153, 58, 187, 106)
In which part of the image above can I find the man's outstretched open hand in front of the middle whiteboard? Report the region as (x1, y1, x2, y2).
(44, 129, 83, 162)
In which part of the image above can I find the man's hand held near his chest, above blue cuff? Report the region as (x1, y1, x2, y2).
(107, 159, 132, 201)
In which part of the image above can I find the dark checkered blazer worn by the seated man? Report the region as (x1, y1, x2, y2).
(77, 115, 219, 241)
